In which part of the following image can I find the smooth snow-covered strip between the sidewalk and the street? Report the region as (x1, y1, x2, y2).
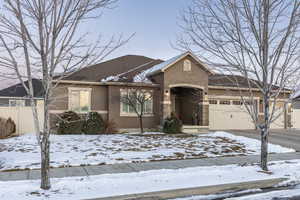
(0, 160, 300, 200)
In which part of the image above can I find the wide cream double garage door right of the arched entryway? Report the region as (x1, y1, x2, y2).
(209, 104, 255, 130)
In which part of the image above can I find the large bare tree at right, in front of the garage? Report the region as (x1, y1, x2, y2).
(177, 0, 300, 170)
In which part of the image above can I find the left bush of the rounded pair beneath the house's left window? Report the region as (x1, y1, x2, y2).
(57, 111, 84, 134)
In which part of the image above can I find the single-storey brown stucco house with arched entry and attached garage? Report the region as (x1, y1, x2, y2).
(0, 52, 291, 131)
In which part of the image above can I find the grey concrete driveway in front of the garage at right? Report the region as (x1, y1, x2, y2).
(228, 129, 300, 152)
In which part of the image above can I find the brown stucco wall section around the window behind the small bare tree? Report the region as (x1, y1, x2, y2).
(108, 86, 160, 128)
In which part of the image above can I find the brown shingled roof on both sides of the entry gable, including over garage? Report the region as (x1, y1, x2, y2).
(65, 55, 284, 88)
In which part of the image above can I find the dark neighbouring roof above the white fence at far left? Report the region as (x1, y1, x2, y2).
(0, 79, 44, 98)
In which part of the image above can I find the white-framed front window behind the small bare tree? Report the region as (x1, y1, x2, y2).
(121, 90, 153, 115)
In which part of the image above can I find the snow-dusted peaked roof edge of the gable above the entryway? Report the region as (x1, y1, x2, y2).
(145, 51, 214, 76)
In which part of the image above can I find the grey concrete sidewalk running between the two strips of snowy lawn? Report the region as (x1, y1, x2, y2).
(0, 152, 300, 181)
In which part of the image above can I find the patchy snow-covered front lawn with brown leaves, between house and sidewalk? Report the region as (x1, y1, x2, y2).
(0, 132, 294, 171)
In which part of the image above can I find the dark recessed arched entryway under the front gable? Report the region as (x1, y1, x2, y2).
(170, 85, 203, 126)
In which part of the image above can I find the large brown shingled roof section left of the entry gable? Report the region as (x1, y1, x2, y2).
(64, 55, 163, 82)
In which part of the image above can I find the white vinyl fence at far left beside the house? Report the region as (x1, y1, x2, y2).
(0, 101, 44, 134)
